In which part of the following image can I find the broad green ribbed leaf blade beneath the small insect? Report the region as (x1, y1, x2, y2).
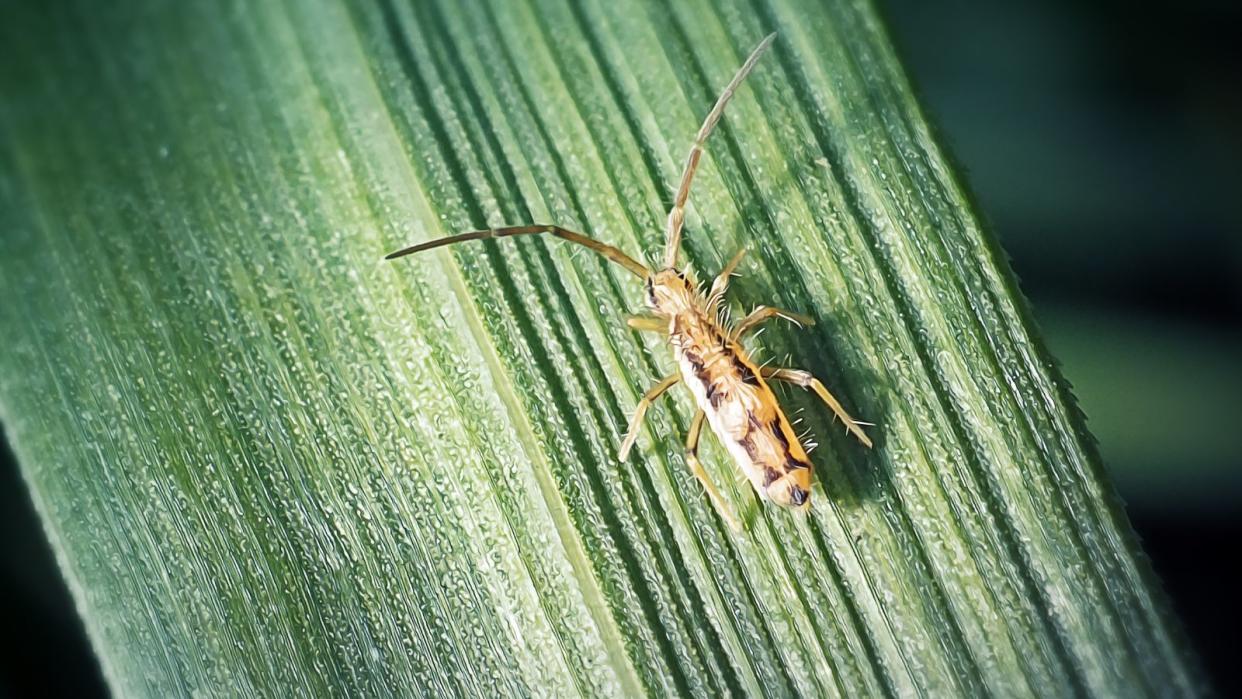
(0, 0, 1202, 697)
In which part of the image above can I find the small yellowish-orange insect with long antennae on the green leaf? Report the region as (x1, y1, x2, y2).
(386, 34, 871, 530)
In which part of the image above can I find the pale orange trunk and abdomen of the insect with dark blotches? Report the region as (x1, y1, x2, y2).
(672, 309, 811, 507)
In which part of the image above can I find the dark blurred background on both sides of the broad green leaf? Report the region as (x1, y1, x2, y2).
(0, 0, 1242, 697)
